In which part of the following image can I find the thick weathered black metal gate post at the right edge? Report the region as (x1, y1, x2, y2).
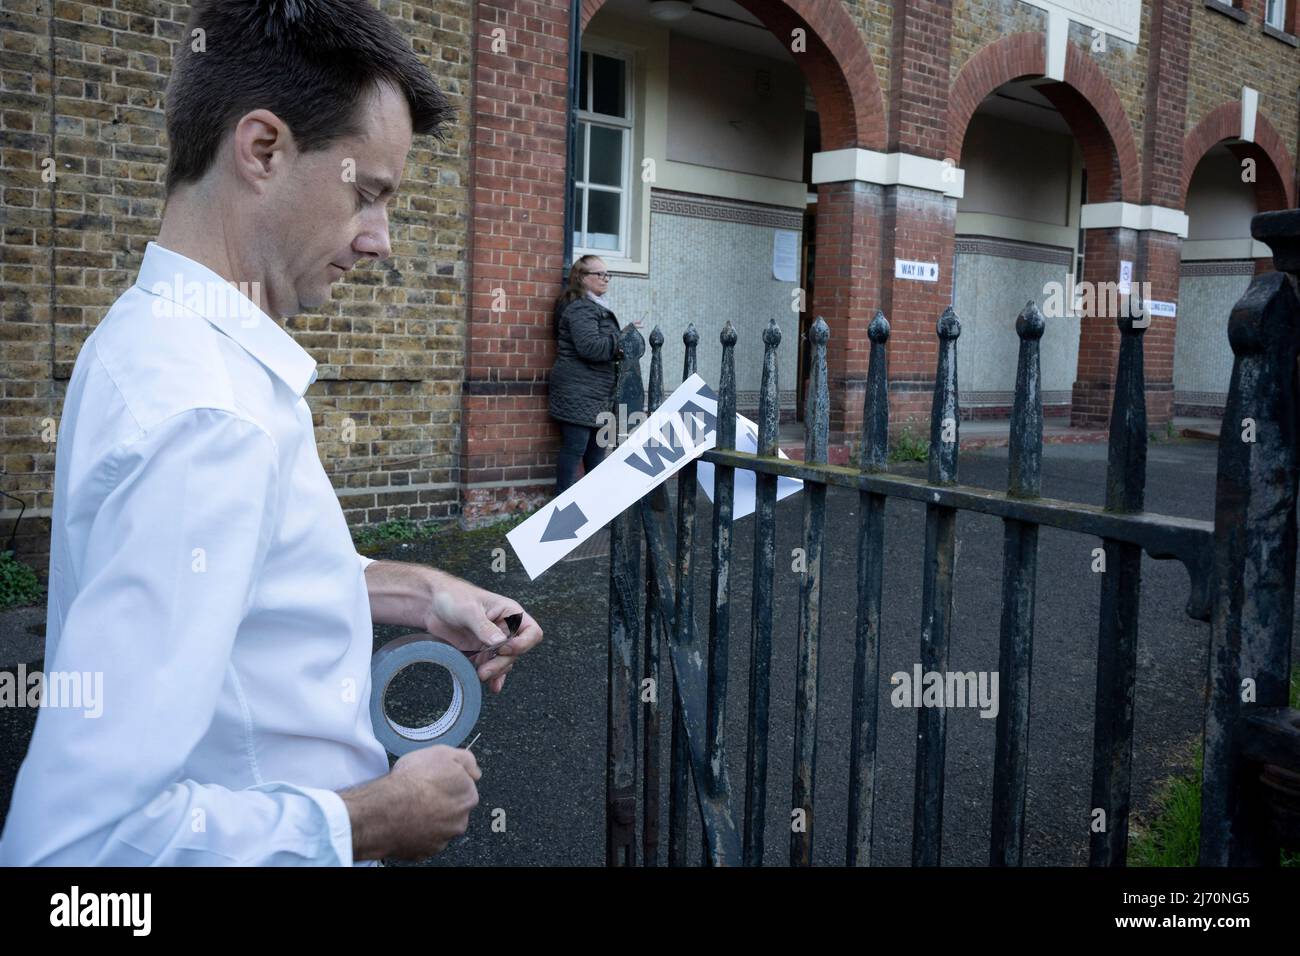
(1200, 209, 1300, 866)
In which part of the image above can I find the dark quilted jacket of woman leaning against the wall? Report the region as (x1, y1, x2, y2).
(550, 291, 619, 428)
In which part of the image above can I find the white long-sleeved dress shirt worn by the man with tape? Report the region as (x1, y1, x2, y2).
(0, 243, 389, 865)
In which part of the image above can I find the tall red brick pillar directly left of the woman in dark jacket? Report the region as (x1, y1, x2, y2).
(460, 0, 568, 525)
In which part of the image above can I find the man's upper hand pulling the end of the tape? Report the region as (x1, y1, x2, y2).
(424, 571, 542, 693)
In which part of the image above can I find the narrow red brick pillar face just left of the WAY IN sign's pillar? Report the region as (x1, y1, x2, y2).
(811, 181, 881, 447)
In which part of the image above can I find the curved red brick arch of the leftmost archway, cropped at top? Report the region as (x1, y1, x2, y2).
(581, 0, 885, 150)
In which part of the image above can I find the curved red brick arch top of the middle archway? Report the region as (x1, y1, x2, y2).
(948, 31, 1141, 203)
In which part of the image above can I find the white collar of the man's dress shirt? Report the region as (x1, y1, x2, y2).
(135, 242, 316, 398)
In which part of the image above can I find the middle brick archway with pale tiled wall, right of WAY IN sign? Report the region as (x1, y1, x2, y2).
(949, 34, 1138, 425)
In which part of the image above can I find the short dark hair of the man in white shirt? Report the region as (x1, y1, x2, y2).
(166, 0, 452, 195)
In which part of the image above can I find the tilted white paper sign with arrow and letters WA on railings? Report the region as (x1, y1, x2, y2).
(506, 375, 718, 580)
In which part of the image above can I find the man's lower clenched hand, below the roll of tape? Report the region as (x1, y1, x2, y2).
(339, 744, 482, 860)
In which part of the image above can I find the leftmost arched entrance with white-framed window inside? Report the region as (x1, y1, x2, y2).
(573, 0, 884, 442)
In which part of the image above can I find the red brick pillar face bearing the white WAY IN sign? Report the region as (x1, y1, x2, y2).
(880, 186, 961, 432)
